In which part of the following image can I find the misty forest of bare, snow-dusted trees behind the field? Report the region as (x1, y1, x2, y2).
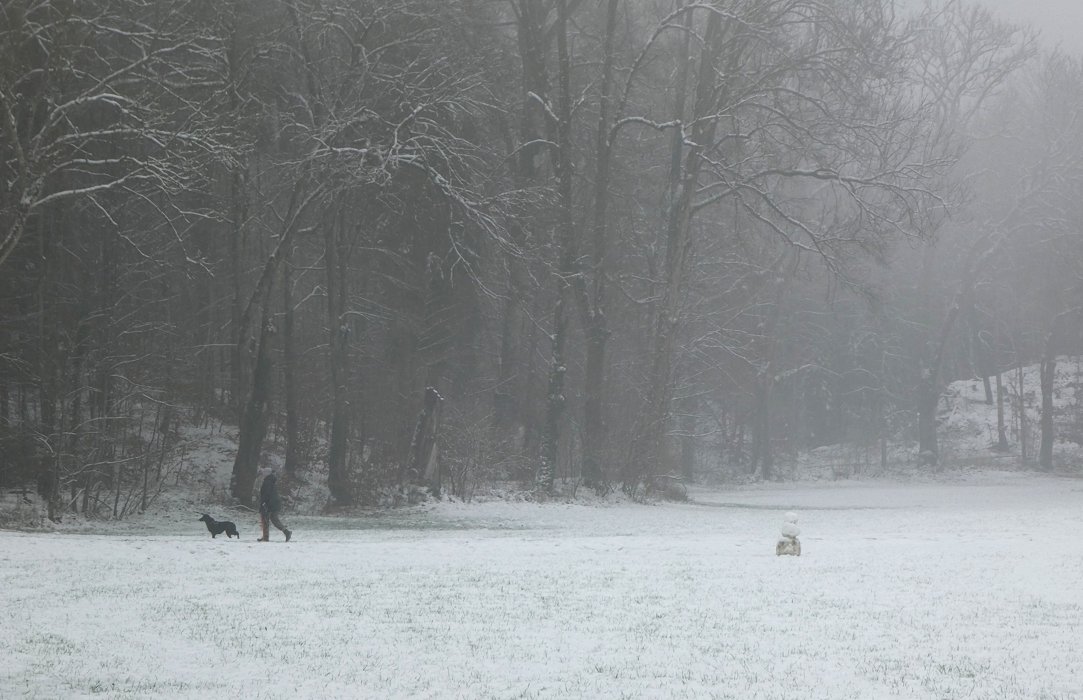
(0, 0, 1083, 515)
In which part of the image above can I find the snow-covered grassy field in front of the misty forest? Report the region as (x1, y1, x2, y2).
(0, 474, 1083, 699)
